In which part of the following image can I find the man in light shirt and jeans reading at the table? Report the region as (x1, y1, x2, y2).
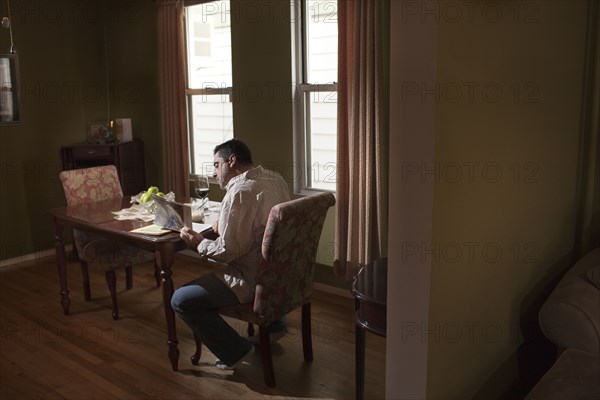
(171, 139, 290, 369)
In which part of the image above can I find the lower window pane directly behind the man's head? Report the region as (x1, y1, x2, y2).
(189, 94, 233, 176)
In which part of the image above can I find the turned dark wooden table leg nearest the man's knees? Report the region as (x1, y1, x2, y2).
(156, 245, 179, 371)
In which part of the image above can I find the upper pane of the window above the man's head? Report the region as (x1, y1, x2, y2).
(186, 0, 233, 89)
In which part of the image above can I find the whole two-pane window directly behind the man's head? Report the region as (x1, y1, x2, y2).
(185, 0, 233, 176)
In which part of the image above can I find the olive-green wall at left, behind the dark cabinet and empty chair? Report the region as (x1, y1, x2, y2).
(0, 1, 161, 260)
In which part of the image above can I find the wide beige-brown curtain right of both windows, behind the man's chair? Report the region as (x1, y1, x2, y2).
(334, 0, 389, 278)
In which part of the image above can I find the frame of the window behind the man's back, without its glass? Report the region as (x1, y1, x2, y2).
(291, 0, 339, 195)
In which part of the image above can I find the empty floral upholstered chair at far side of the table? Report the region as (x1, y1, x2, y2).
(59, 165, 160, 319)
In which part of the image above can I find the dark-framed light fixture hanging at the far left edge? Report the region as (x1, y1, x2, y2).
(0, 0, 22, 124)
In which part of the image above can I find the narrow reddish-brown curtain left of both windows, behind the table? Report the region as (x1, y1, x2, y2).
(156, 0, 190, 199)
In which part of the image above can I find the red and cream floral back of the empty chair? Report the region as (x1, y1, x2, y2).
(59, 165, 123, 206)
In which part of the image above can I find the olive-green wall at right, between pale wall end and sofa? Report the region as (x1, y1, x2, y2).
(427, 1, 587, 399)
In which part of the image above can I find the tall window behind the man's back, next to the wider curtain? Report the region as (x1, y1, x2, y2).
(292, 0, 338, 192)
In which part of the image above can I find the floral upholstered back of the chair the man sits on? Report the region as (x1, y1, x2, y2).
(254, 193, 335, 322)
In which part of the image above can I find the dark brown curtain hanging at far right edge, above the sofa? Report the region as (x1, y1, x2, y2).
(575, 1, 600, 258)
